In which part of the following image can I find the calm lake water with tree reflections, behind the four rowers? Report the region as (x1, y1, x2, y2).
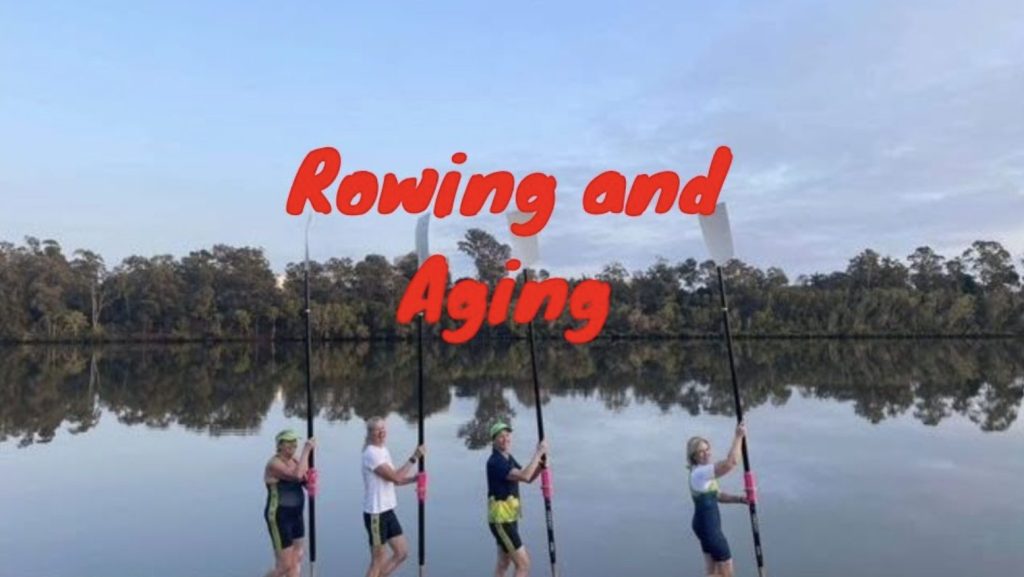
(0, 340, 1024, 577)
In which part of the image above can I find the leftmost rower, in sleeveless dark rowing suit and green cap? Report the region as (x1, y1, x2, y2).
(263, 430, 316, 577)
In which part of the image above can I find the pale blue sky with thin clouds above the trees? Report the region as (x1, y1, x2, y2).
(0, 0, 1024, 277)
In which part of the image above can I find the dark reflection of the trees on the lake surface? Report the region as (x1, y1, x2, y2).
(0, 340, 1024, 448)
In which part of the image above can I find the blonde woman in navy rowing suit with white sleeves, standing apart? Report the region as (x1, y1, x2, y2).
(686, 423, 746, 577)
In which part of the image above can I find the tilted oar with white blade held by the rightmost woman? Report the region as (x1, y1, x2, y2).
(700, 203, 765, 577)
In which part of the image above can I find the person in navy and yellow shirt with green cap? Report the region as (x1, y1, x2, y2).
(487, 422, 548, 577)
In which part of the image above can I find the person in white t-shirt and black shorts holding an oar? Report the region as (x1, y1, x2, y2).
(362, 417, 424, 577)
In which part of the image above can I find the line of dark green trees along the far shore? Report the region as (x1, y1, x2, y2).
(0, 233, 1024, 341)
